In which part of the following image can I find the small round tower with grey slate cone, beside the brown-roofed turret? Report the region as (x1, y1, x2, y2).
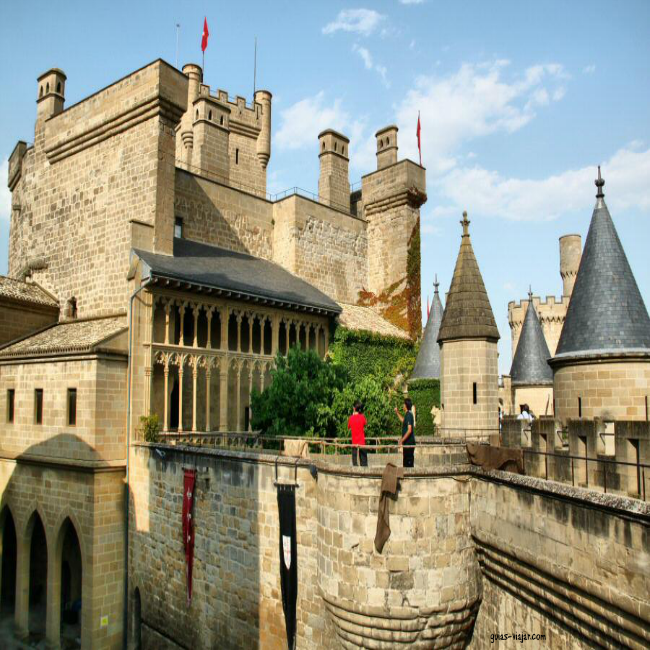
(510, 291, 553, 416)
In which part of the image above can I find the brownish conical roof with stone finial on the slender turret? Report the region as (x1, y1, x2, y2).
(438, 212, 499, 343)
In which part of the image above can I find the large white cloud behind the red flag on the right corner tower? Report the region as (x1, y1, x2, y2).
(397, 60, 568, 175)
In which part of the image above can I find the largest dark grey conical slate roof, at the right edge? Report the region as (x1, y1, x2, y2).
(555, 167, 650, 358)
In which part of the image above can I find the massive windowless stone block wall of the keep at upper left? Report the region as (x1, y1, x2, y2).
(9, 61, 187, 317)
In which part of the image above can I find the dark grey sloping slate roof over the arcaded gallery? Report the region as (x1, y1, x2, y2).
(134, 238, 341, 314)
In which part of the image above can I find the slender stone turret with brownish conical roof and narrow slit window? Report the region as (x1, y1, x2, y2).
(438, 212, 499, 435)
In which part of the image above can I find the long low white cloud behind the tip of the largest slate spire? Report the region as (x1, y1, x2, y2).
(434, 143, 650, 221)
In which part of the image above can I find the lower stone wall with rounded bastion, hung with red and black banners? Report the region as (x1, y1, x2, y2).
(130, 445, 650, 650)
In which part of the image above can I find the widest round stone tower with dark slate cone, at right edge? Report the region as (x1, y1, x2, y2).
(550, 167, 650, 422)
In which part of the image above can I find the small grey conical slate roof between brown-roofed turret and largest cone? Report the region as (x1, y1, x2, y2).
(510, 293, 553, 386)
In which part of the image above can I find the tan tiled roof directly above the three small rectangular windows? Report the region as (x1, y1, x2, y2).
(0, 316, 128, 359)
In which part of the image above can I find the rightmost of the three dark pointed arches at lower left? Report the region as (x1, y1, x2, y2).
(60, 519, 82, 648)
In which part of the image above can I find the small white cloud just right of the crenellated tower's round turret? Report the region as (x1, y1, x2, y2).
(274, 90, 349, 149)
